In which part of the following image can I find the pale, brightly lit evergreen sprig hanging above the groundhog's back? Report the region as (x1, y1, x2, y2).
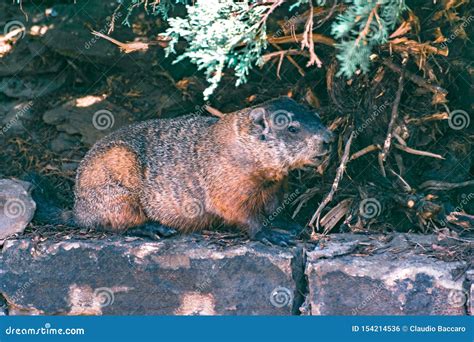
(165, 0, 267, 99)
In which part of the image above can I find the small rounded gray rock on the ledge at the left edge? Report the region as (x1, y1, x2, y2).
(0, 179, 36, 244)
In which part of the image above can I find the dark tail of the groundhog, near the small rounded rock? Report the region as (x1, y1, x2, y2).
(23, 172, 76, 227)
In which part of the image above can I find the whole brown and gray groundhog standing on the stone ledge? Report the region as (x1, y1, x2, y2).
(73, 97, 333, 244)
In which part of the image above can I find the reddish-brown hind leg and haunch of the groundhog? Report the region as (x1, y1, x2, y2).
(74, 146, 147, 231)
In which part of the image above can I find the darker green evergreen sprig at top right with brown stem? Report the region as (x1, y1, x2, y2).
(332, 0, 406, 78)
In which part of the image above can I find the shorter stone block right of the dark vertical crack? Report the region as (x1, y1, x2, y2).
(303, 234, 467, 315)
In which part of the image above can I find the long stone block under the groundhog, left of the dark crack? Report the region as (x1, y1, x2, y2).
(0, 236, 303, 315)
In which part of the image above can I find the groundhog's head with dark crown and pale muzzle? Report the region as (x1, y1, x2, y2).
(249, 97, 334, 169)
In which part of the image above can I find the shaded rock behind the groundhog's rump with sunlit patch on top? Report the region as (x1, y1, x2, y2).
(43, 96, 133, 146)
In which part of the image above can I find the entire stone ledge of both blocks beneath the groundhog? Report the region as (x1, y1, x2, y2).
(0, 234, 474, 315)
